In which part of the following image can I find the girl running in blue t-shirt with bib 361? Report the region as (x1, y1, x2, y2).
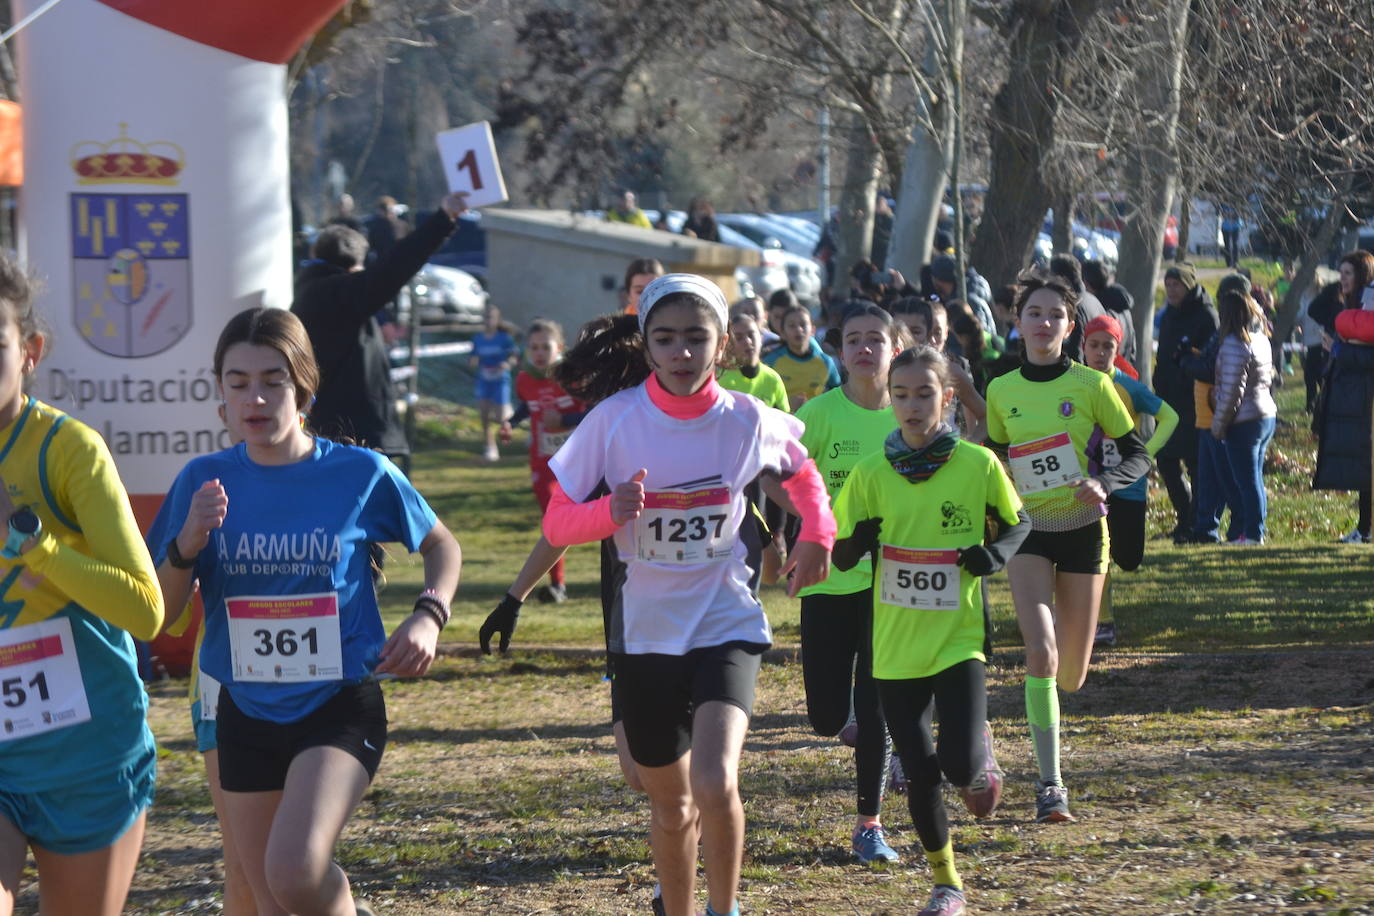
(148, 309, 462, 916)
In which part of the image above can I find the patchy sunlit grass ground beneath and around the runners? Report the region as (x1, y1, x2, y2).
(18, 362, 1374, 916)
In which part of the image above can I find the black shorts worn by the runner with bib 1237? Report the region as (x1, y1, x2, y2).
(611, 643, 768, 766)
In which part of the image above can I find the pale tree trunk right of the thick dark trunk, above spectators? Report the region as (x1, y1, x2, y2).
(1117, 0, 1189, 379)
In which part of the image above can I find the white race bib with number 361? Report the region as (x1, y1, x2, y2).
(224, 592, 344, 684)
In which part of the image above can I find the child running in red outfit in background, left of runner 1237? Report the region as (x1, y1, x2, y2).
(502, 319, 584, 604)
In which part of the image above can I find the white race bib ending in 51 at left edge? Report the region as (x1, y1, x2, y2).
(0, 617, 91, 742)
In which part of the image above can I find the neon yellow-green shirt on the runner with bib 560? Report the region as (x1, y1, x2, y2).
(835, 441, 1021, 680)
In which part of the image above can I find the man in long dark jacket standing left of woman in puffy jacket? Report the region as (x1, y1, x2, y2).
(1151, 262, 1219, 544)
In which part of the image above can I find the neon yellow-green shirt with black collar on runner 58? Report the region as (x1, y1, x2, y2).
(988, 363, 1135, 531)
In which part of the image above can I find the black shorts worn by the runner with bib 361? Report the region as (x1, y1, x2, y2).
(216, 681, 386, 792)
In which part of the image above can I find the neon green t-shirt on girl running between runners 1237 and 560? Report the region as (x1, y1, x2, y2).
(797, 389, 897, 597)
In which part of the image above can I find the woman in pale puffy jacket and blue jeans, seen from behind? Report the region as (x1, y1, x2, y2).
(1212, 291, 1278, 544)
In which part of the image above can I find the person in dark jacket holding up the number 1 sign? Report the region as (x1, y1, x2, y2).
(291, 194, 467, 468)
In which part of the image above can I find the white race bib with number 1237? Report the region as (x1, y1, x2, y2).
(635, 486, 735, 566)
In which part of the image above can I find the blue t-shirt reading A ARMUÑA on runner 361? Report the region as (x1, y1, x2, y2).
(148, 439, 437, 722)
